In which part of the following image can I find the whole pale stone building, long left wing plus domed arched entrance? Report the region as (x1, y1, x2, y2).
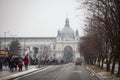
(0, 18, 80, 60)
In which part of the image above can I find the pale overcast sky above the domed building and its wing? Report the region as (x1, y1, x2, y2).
(0, 0, 86, 37)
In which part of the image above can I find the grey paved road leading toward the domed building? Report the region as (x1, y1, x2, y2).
(15, 63, 95, 80)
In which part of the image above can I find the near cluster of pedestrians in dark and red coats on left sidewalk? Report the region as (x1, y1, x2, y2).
(2, 55, 29, 71)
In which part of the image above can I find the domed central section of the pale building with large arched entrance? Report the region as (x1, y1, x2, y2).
(55, 18, 80, 60)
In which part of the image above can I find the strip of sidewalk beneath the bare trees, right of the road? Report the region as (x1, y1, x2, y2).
(86, 65, 120, 80)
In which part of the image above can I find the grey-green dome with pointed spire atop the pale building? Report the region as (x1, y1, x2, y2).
(61, 18, 74, 37)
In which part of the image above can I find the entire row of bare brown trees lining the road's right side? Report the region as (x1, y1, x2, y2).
(79, 0, 120, 76)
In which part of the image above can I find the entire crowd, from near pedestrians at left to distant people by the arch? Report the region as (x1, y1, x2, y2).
(0, 55, 71, 72)
